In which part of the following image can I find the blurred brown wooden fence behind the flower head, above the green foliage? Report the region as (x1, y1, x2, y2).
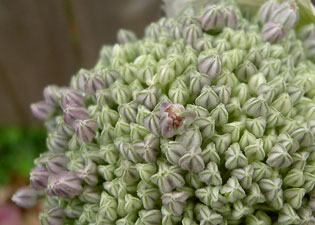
(0, 0, 163, 124)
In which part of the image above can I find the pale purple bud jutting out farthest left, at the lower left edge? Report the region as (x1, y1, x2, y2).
(12, 186, 37, 208)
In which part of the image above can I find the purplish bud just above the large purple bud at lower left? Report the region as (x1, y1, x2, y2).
(46, 154, 69, 174)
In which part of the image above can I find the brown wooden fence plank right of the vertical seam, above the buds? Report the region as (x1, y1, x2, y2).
(71, 0, 161, 67)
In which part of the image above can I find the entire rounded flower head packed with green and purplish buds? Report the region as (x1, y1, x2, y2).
(12, 0, 315, 225)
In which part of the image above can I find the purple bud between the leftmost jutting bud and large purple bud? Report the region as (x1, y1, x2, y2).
(30, 166, 50, 191)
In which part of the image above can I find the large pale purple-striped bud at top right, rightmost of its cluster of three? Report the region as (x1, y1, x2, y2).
(270, 0, 299, 30)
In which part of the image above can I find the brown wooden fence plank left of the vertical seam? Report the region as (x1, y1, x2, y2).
(0, 0, 75, 123)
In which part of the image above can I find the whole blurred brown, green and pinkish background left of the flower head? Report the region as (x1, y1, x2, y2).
(0, 0, 163, 225)
